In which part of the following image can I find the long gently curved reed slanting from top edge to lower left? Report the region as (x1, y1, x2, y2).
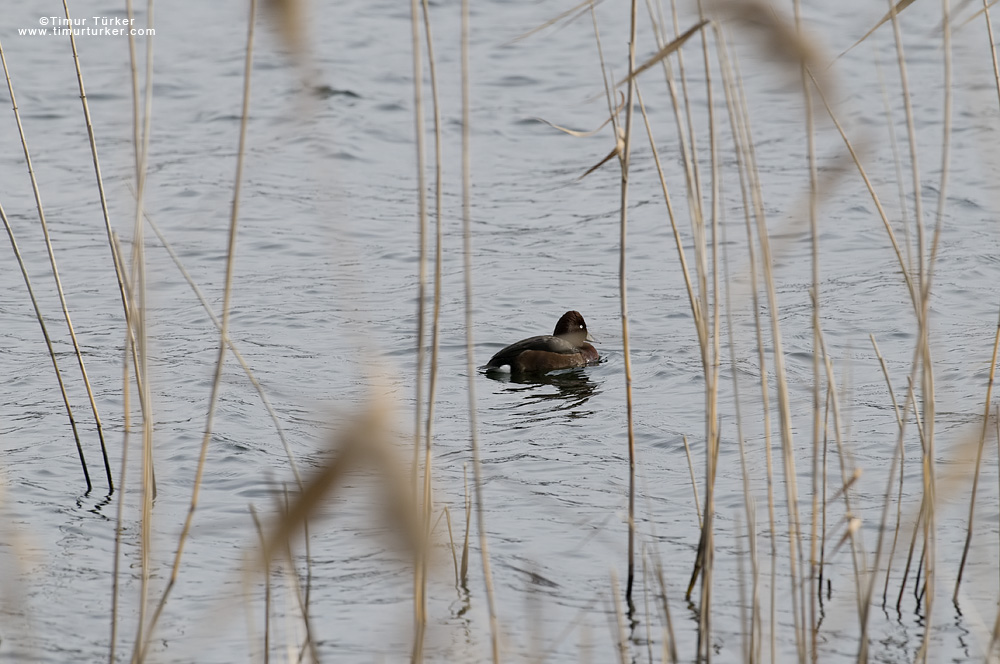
(140, 0, 257, 660)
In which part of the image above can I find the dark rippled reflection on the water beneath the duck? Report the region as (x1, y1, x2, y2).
(486, 368, 601, 417)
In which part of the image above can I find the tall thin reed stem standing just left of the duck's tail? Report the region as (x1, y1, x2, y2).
(461, 0, 500, 664)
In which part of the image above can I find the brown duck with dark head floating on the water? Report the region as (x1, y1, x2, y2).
(484, 311, 601, 374)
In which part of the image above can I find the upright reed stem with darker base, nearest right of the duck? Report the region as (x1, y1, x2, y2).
(615, 0, 636, 613)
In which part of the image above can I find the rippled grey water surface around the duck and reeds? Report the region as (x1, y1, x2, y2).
(0, 1, 1000, 662)
